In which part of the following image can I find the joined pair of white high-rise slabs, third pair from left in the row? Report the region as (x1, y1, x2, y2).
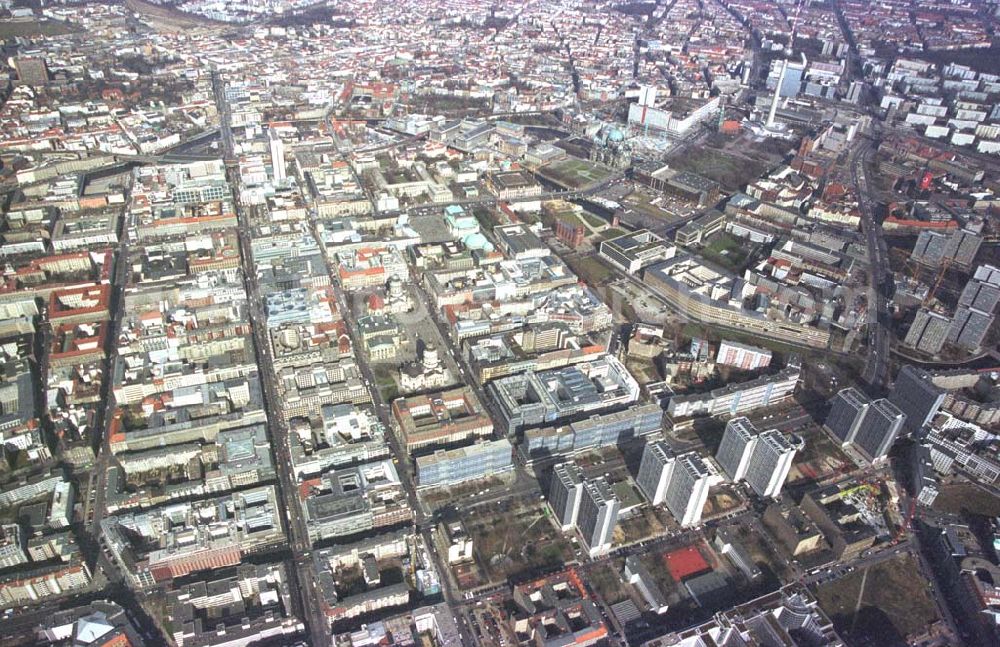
(716, 418, 796, 498)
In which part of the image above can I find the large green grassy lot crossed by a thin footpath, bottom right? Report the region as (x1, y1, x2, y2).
(816, 553, 938, 645)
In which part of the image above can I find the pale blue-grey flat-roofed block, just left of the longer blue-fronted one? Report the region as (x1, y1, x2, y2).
(417, 438, 514, 488)
